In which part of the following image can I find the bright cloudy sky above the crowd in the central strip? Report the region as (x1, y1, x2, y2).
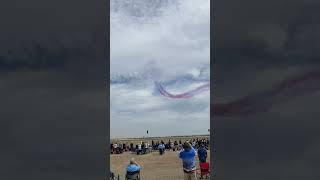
(110, 0, 210, 138)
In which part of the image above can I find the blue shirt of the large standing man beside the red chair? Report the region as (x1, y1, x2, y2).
(179, 148, 197, 171)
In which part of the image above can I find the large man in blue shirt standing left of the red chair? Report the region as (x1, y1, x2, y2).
(179, 142, 197, 180)
